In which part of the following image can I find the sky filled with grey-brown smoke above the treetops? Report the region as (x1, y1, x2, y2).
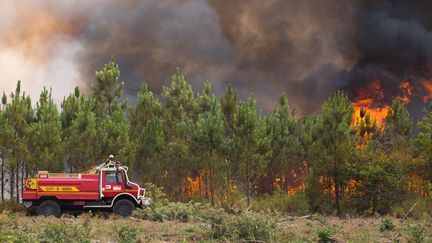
(0, 0, 432, 113)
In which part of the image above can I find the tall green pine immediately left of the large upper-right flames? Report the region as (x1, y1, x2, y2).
(312, 91, 356, 215)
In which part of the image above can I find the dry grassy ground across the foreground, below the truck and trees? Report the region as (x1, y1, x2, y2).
(0, 212, 432, 242)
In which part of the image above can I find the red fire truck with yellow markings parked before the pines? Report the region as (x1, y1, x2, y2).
(22, 165, 150, 217)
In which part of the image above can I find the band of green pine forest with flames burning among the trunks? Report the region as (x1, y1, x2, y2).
(0, 58, 432, 215)
